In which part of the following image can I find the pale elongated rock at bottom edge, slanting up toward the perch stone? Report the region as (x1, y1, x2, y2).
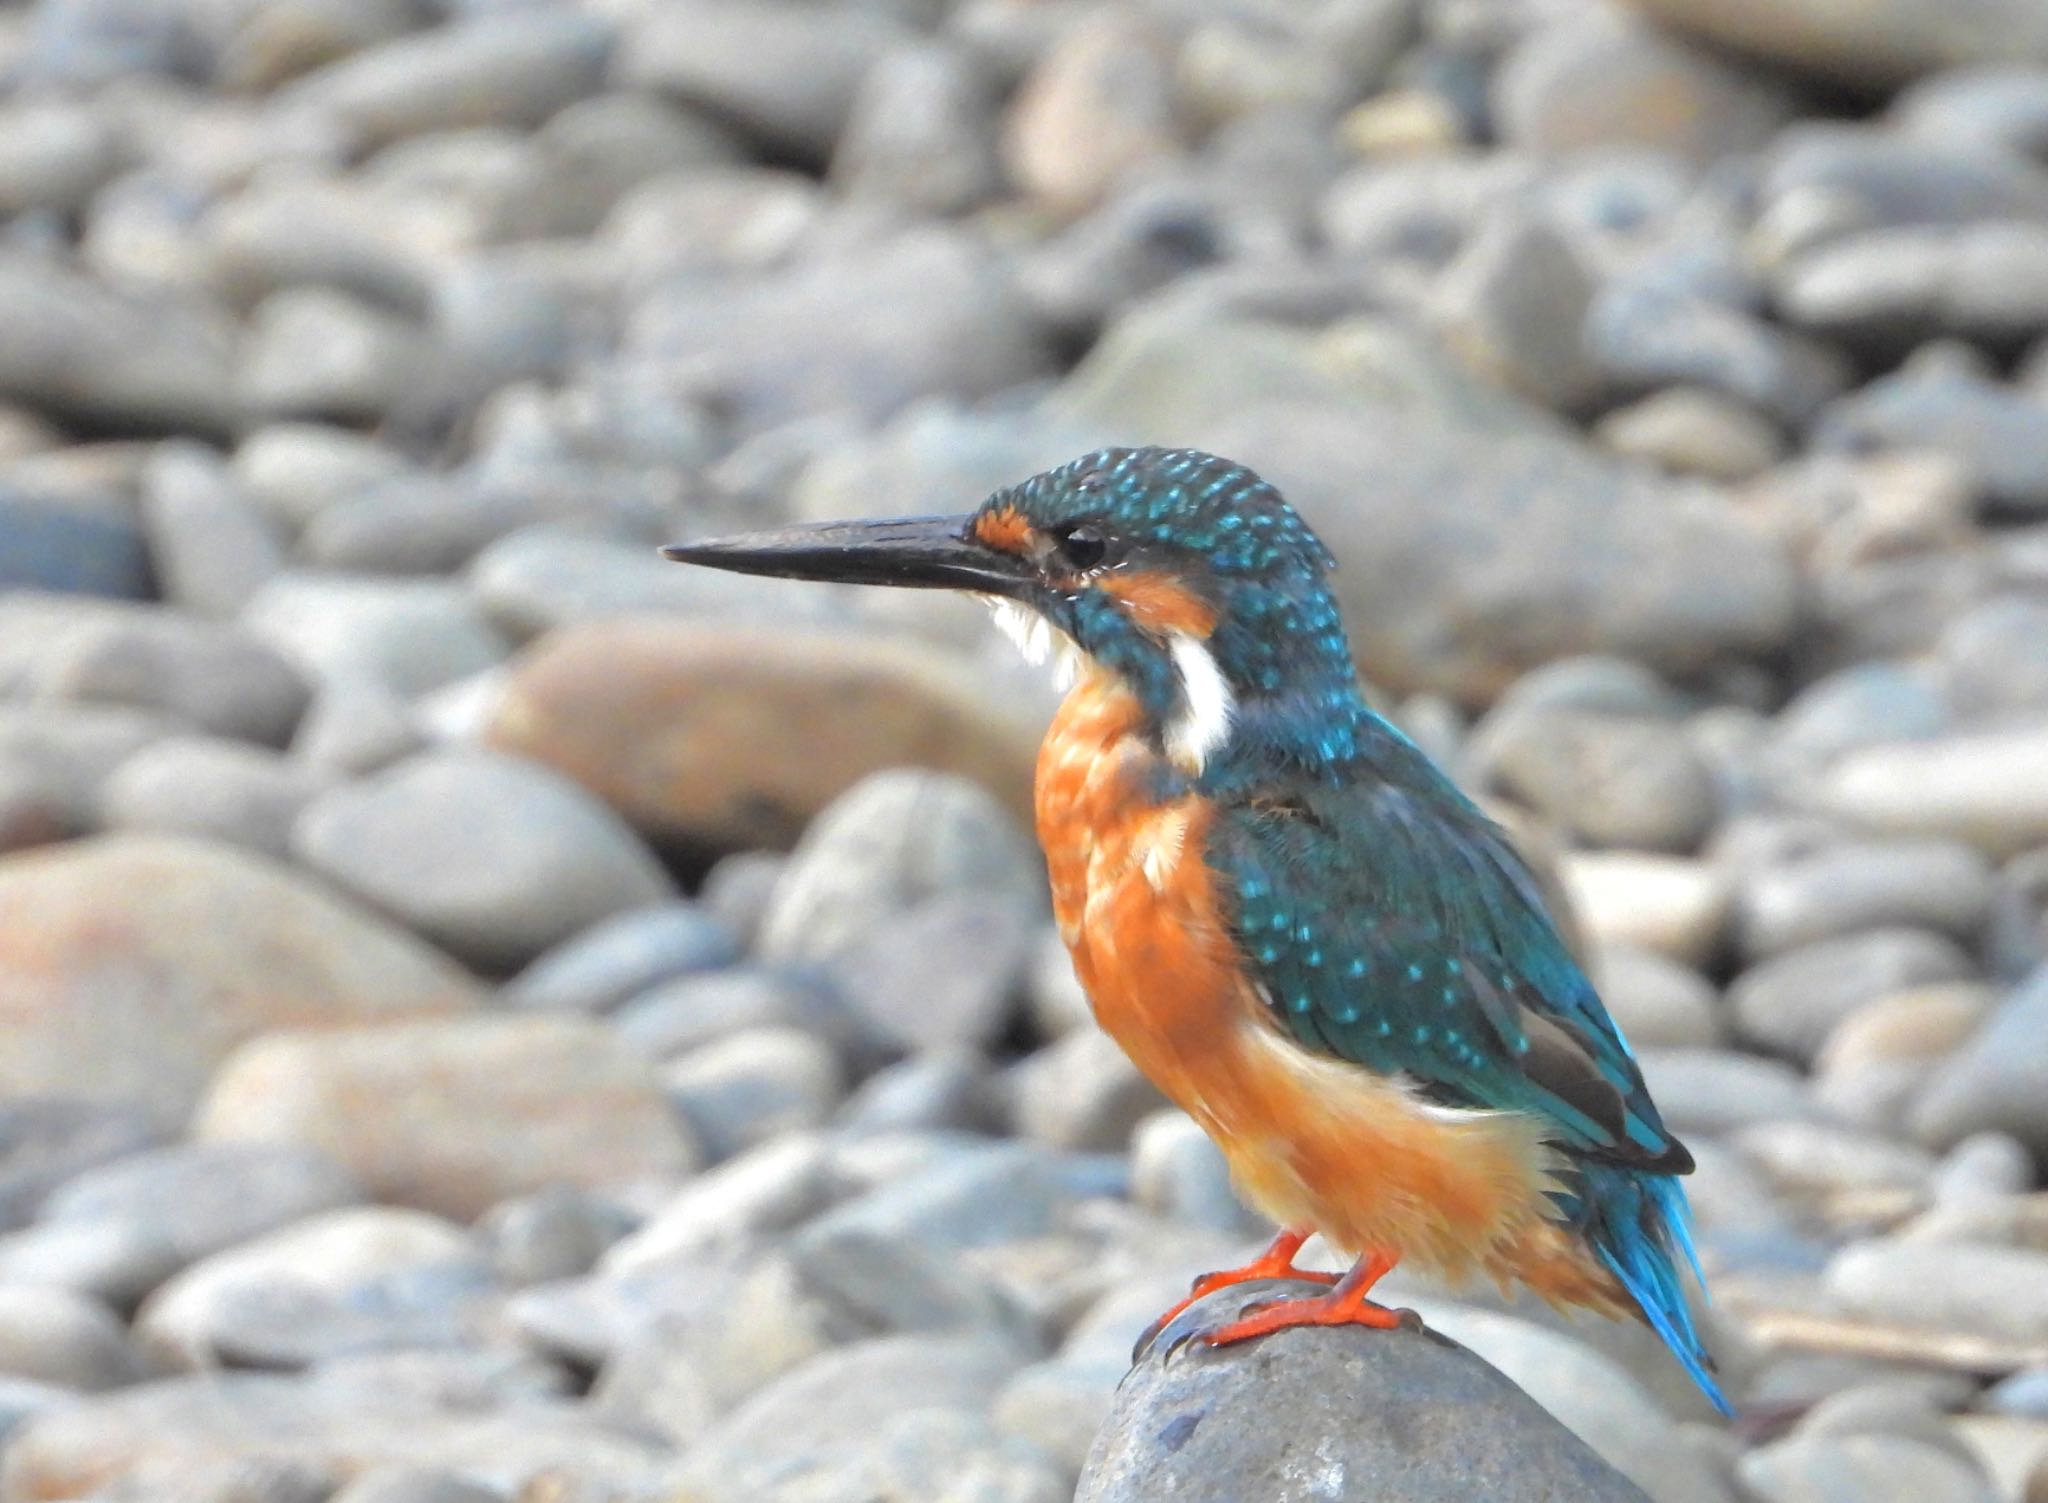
(684, 1335, 1042, 1503)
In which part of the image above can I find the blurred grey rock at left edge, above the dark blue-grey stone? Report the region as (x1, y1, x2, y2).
(0, 252, 242, 436)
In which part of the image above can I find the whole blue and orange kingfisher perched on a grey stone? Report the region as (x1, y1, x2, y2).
(664, 448, 1729, 1413)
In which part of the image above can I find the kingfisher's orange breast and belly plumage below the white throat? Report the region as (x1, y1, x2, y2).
(1036, 672, 1618, 1306)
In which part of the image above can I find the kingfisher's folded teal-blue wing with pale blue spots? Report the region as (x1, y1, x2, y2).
(1208, 757, 1692, 1173)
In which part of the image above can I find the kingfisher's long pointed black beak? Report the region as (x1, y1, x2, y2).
(662, 516, 1038, 596)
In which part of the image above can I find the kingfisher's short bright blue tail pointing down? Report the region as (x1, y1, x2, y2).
(1581, 1163, 1735, 1417)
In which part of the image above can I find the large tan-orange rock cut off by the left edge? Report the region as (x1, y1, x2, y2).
(0, 835, 477, 1124)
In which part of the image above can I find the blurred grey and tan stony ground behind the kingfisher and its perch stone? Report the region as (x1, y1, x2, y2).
(0, 0, 2048, 1503)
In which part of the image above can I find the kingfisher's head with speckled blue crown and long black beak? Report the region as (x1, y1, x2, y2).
(664, 448, 1362, 772)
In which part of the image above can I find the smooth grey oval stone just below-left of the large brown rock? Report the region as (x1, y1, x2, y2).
(293, 752, 670, 969)
